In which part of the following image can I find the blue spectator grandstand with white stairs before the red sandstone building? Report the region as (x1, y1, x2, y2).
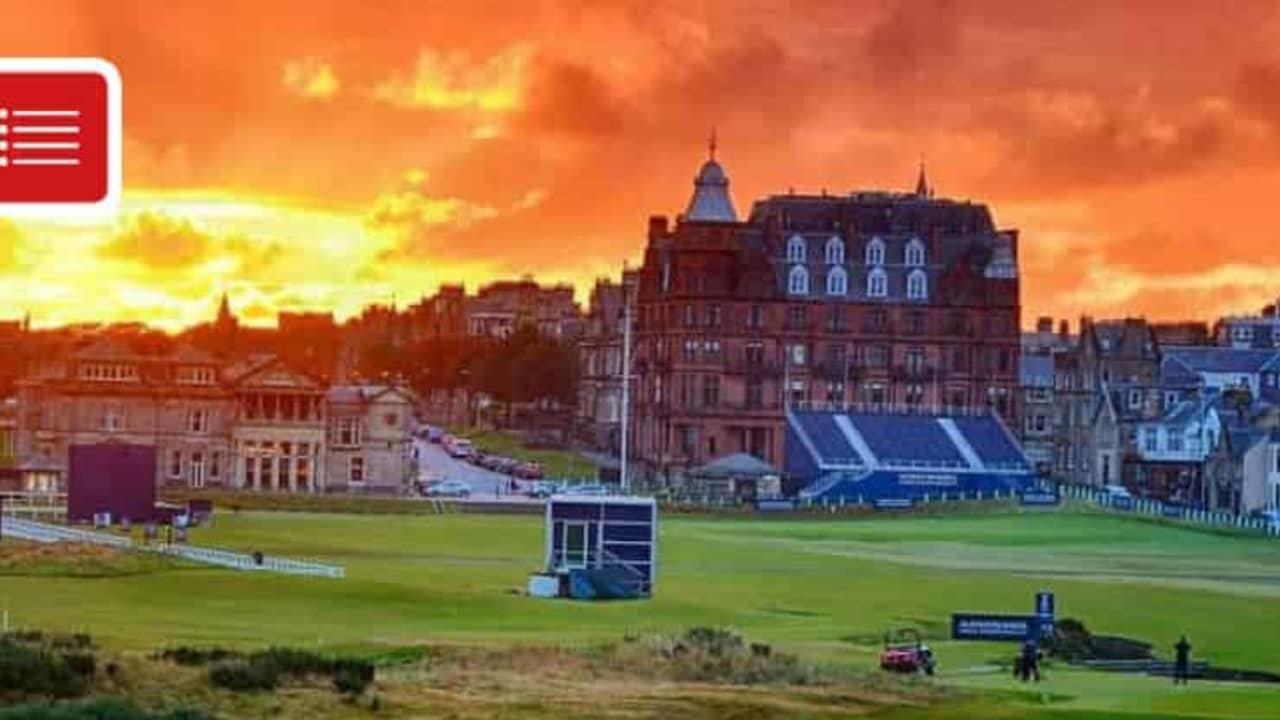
(786, 411, 1034, 502)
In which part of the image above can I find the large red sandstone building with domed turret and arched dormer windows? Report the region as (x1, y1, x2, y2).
(632, 149, 1019, 482)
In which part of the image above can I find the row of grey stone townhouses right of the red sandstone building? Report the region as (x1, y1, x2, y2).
(1020, 318, 1280, 512)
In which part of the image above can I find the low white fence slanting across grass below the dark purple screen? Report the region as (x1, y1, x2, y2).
(0, 516, 347, 578)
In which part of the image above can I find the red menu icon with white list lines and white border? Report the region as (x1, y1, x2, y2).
(0, 58, 120, 214)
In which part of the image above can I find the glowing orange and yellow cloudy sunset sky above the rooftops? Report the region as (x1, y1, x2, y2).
(0, 0, 1280, 328)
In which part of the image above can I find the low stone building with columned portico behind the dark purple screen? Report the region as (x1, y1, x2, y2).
(13, 336, 413, 493)
